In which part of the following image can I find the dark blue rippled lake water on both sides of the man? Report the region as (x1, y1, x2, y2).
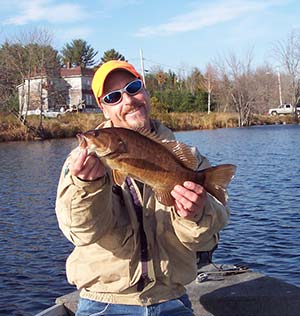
(0, 125, 300, 316)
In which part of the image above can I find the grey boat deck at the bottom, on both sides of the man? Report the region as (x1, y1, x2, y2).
(36, 265, 300, 316)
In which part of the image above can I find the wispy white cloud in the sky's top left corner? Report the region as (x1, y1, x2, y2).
(3, 0, 87, 25)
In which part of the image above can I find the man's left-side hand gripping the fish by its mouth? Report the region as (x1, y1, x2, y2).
(69, 147, 106, 181)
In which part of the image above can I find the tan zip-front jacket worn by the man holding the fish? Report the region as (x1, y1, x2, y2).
(56, 122, 229, 305)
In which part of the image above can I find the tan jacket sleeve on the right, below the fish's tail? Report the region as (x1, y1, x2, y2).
(171, 148, 230, 251)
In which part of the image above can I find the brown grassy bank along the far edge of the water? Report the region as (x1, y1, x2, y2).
(0, 112, 293, 142)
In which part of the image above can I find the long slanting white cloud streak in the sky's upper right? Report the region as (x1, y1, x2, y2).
(135, 0, 284, 37)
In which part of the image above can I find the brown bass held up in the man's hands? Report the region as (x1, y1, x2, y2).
(77, 127, 236, 206)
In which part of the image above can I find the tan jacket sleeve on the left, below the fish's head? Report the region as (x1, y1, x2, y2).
(56, 158, 115, 246)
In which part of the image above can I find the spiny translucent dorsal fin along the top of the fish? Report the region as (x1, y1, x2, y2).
(135, 128, 199, 170)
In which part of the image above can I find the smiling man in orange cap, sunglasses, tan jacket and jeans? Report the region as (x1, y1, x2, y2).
(56, 61, 229, 316)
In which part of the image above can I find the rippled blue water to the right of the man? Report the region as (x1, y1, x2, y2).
(177, 126, 300, 285)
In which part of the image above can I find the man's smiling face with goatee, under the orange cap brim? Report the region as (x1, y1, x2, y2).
(101, 70, 150, 129)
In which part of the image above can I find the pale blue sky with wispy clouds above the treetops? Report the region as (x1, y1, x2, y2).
(0, 0, 300, 72)
